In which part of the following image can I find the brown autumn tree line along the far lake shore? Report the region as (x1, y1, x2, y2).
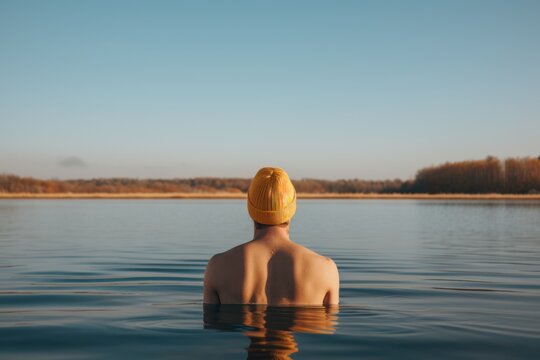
(0, 156, 540, 194)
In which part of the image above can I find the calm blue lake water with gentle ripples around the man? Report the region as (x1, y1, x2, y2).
(0, 200, 540, 359)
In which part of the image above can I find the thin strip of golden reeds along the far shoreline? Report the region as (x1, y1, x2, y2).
(0, 192, 540, 200)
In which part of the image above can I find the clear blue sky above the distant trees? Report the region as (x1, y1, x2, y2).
(0, 0, 540, 179)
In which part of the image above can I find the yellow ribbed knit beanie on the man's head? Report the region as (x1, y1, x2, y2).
(247, 167, 296, 225)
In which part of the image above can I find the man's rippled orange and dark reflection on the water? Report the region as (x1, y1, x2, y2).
(204, 304, 339, 359)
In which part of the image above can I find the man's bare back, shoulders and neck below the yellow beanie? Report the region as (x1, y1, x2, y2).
(204, 226, 339, 305)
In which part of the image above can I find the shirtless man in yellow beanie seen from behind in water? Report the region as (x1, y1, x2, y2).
(204, 167, 339, 305)
